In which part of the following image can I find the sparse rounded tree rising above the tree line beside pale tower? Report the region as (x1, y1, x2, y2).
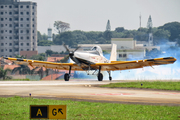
(54, 21, 70, 34)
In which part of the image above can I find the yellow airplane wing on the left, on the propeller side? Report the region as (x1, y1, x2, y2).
(3, 57, 83, 71)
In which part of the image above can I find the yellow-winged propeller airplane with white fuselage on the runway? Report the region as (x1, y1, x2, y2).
(2, 44, 176, 81)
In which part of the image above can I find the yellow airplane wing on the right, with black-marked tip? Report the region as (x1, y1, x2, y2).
(91, 57, 176, 71)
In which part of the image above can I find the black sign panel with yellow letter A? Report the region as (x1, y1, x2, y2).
(30, 105, 48, 119)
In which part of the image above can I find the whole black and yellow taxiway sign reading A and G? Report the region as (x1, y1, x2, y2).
(30, 105, 67, 119)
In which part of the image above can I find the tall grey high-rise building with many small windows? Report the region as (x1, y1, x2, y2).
(0, 0, 37, 57)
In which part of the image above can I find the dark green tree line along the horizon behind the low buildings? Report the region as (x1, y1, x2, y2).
(37, 21, 180, 47)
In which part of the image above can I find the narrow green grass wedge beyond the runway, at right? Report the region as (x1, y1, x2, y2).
(101, 81, 180, 91)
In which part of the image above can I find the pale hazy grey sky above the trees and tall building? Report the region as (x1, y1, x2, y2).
(20, 0, 180, 34)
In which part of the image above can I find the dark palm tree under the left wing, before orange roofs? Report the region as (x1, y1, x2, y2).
(12, 65, 30, 75)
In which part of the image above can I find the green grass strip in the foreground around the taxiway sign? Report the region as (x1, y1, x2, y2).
(0, 96, 180, 120)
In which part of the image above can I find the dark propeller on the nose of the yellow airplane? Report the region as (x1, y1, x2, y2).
(63, 43, 81, 66)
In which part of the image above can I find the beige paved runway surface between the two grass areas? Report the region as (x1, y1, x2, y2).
(0, 80, 180, 106)
